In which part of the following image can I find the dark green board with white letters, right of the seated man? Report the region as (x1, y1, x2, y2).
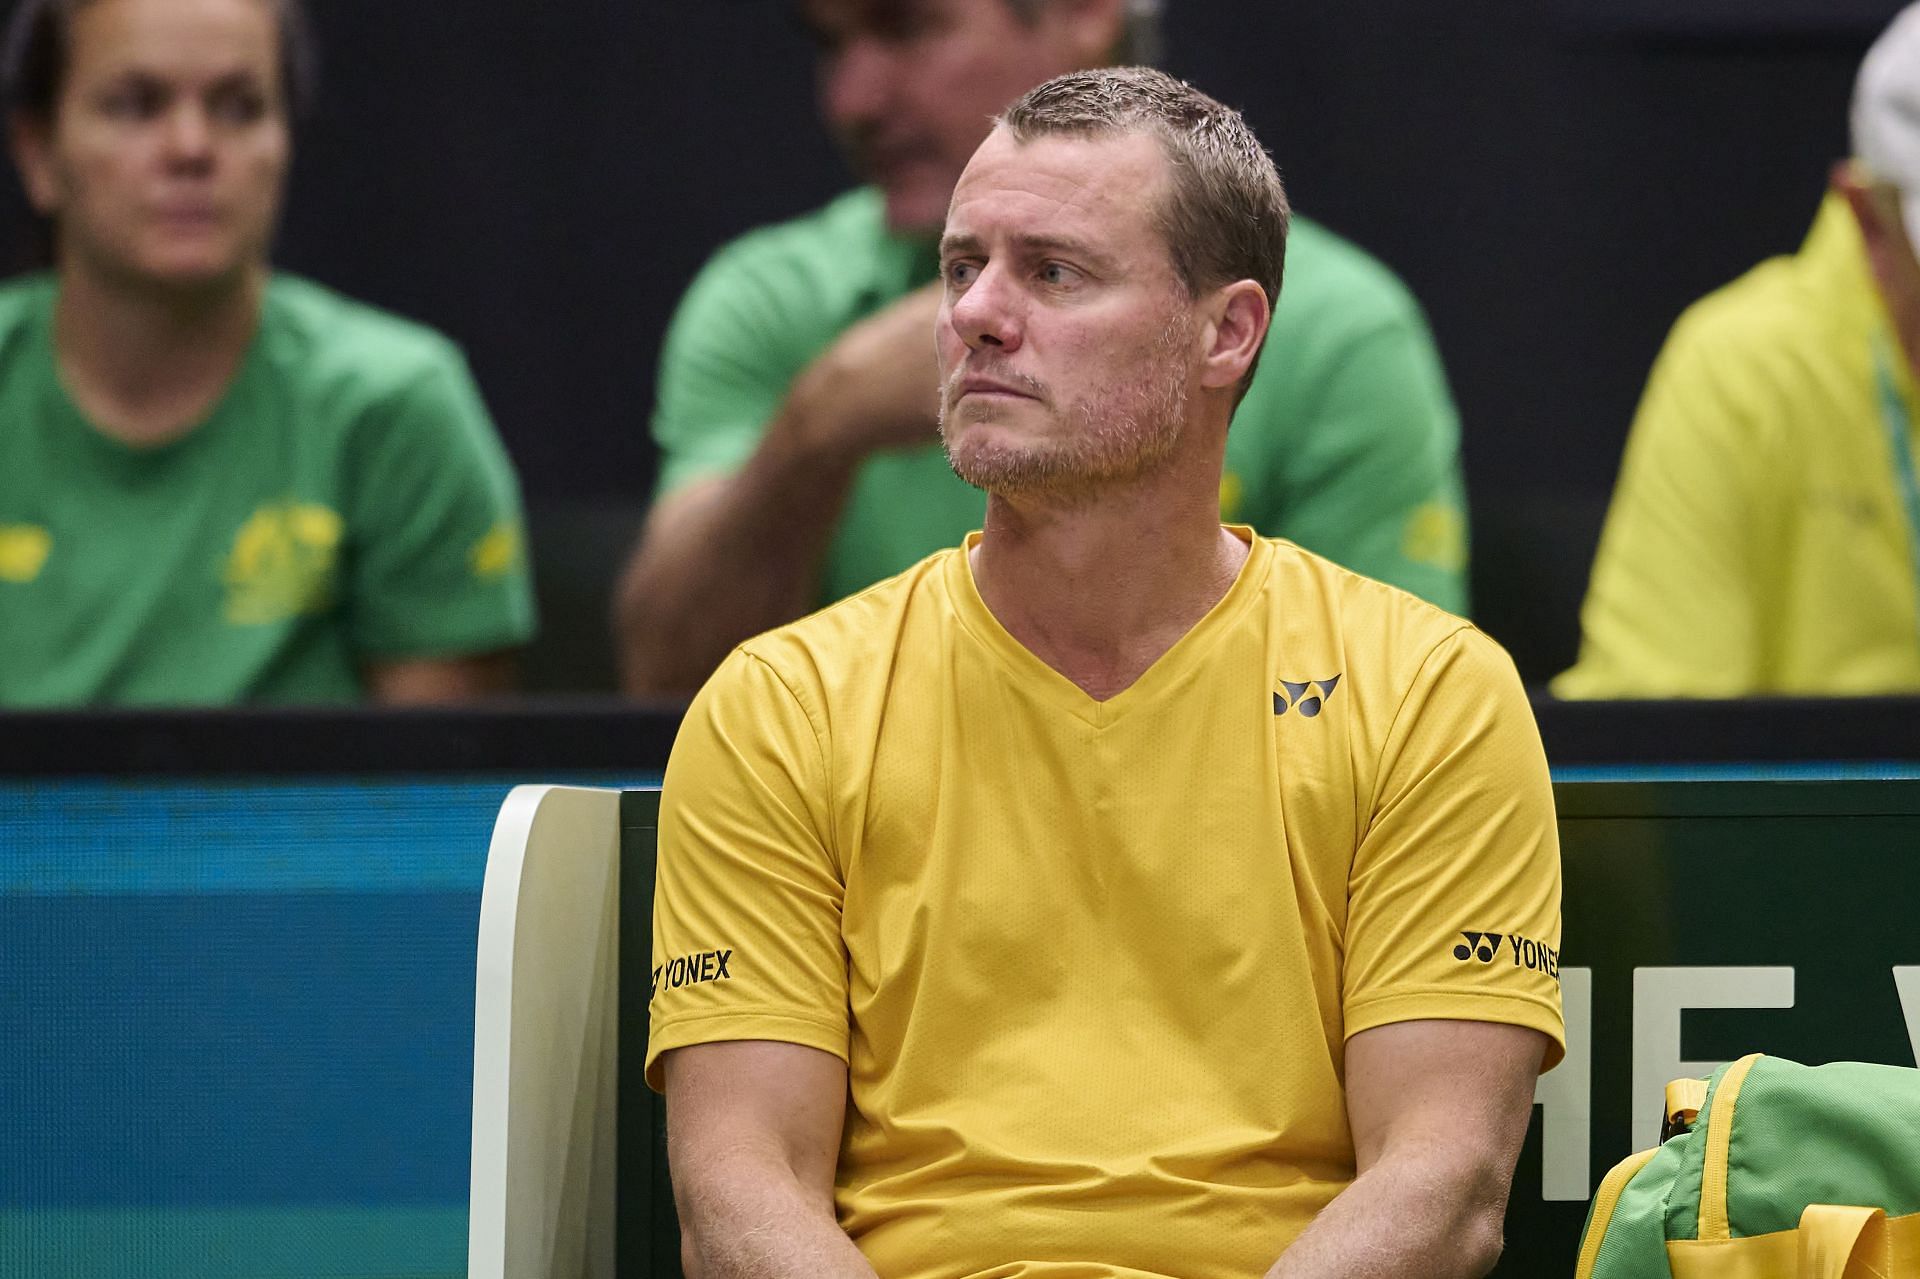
(1497, 780, 1920, 1277)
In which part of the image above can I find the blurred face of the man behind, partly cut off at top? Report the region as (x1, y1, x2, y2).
(801, 0, 1117, 234)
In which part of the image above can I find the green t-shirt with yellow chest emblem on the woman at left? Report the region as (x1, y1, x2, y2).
(0, 275, 534, 707)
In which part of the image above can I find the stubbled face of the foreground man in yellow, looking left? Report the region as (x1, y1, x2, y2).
(935, 129, 1198, 499)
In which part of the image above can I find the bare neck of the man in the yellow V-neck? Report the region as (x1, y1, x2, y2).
(972, 455, 1248, 701)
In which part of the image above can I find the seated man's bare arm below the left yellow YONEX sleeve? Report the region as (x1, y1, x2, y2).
(660, 1039, 874, 1279)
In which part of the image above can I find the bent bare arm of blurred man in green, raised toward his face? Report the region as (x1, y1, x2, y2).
(614, 286, 939, 695)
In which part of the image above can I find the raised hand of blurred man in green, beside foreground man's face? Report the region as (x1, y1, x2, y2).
(785, 280, 941, 463)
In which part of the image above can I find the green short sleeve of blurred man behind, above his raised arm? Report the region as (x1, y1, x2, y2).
(653, 238, 817, 497)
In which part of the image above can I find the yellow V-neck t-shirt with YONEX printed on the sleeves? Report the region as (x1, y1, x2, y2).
(647, 530, 1561, 1279)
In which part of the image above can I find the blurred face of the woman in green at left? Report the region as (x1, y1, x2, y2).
(15, 0, 288, 286)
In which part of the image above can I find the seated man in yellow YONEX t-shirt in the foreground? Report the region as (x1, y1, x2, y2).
(647, 69, 1561, 1279)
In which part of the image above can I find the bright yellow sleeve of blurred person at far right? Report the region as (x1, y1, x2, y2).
(1553, 317, 1791, 697)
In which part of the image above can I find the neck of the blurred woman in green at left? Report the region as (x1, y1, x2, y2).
(54, 267, 267, 446)
